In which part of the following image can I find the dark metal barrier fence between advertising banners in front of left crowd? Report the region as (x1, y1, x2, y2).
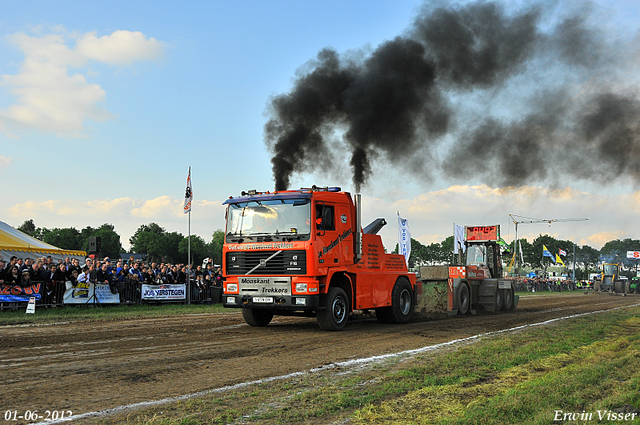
(0, 281, 222, 311)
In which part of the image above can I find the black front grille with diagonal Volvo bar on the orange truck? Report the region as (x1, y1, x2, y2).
(226, 250, 307, 276)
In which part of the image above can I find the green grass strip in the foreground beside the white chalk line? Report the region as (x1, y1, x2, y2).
(80, 300, 640, 425)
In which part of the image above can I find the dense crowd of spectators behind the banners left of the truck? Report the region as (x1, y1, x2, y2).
(0, 256, 222, 304)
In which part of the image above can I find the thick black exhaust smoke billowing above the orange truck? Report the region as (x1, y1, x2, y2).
(265, 2, 640, 191)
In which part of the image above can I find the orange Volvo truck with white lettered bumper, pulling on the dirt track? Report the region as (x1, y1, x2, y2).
(222, 186, 416, 331)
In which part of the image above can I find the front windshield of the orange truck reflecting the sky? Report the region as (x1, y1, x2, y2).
(227, 199, 311, 239)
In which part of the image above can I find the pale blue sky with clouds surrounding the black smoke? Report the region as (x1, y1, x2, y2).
(0, 0, 640, 249)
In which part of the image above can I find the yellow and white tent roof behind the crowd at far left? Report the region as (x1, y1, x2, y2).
(0, 221, 87, 262)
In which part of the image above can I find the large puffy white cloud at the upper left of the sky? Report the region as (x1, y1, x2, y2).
(0, 31, 164, 137)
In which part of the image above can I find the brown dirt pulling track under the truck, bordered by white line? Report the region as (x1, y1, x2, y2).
(0, 292, 640, 424)
